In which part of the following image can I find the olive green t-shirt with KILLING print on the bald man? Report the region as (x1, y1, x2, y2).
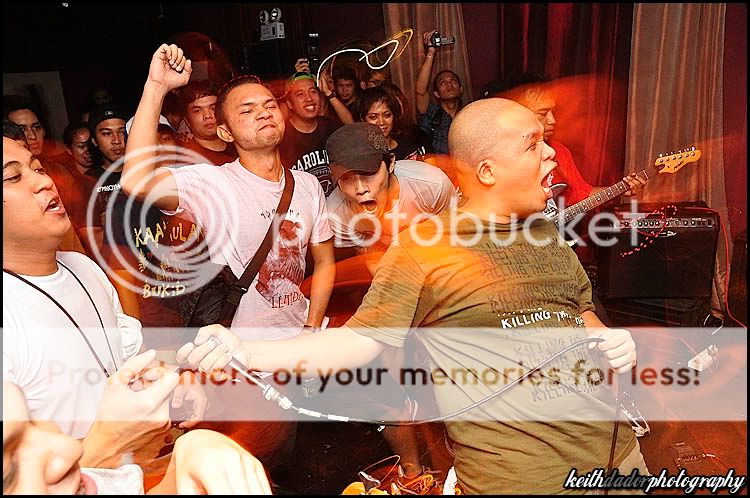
(346, 212, 635, 494)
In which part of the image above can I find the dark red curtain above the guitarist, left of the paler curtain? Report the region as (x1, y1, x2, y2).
(498, 3, 646, 186)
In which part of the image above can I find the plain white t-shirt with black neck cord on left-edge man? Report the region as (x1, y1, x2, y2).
(3, 252, 143, 439)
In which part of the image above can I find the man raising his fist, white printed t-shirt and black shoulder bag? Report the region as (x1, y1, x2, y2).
(122, 44, 335, 466)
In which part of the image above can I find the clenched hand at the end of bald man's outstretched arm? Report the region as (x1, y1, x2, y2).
(176, 325, 249, 373)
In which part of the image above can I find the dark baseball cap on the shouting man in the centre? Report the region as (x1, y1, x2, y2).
(326, 123, 390, 183)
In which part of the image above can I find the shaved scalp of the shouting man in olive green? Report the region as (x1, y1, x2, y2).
(448, 98, 528, 174)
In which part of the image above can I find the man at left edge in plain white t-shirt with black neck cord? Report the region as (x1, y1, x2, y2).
(3, 136, 187, 467)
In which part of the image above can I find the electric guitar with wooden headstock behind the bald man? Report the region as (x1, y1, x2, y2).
(544, 147, 701, 226)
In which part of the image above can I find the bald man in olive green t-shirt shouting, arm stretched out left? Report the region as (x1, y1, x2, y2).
(178, 99, 648, 494)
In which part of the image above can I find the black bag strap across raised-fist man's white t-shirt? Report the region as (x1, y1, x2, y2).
(219, 168, 294, 327)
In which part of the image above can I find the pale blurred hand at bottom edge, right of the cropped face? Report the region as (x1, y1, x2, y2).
(149, 429, 271, 495)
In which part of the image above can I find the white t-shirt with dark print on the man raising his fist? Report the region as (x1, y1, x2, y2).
(171, 160, 333, 339)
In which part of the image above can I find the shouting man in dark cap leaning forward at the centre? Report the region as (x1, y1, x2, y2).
(326, 123, 457, 272)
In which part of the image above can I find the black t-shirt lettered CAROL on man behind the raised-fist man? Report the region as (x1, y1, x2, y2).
(279, 116, 341, 197)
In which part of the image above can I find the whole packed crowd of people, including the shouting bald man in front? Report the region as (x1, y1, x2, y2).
(3, 32, 648, 494)
